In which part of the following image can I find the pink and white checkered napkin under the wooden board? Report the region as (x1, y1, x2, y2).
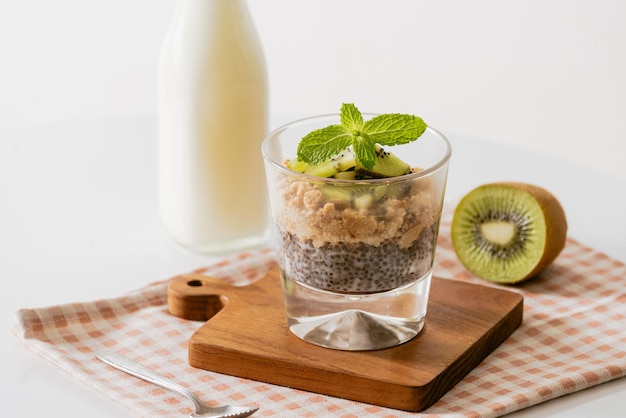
(16, 208, 626, 418)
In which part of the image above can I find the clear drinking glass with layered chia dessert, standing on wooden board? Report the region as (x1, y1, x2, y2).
(262, 114, 451, 350)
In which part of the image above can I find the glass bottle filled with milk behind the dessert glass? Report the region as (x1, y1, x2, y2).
(158, 0, 269, 253)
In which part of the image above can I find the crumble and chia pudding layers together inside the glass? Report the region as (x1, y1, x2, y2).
(272, 168, 443, 294)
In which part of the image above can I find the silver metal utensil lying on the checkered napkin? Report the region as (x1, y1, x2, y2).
(96, 352, 259, 418)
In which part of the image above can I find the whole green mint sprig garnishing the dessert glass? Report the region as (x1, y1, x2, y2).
(298, 103, 427, 170)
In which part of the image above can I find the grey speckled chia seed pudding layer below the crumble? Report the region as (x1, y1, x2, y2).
(277, 224, 437, 293)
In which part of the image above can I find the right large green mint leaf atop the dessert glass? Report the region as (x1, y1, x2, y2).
(362, 113, 427, 145)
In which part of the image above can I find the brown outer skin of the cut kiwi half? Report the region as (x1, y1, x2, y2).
(452, 182, 567, 284)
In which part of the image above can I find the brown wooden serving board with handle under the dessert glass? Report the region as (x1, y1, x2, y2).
(168, 269, 523, 411)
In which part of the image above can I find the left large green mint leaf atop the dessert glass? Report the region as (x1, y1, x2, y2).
(298, 125, 352, 165)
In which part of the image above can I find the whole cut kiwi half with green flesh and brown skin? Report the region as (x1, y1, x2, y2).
(451, 183, 567, 284)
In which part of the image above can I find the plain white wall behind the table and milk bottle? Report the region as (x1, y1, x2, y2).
(0, 0, 626, 183)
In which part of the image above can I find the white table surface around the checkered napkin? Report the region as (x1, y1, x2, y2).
(0, 112, 626, 418)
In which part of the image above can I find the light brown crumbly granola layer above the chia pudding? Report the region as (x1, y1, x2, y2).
(275, 176, 439, 248)
